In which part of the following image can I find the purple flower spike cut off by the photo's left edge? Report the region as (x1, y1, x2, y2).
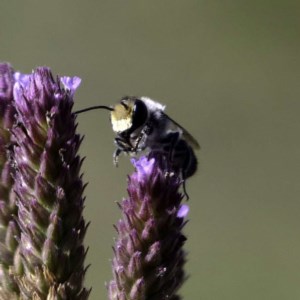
(0, 63, 19, 299)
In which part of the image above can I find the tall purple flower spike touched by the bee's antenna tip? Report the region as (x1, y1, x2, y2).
(11, 68, 89, 300)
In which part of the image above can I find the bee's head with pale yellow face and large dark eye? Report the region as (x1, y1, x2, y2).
(110, 97, 148, 133)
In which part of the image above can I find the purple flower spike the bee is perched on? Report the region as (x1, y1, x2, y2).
(108, 155, 187, 300)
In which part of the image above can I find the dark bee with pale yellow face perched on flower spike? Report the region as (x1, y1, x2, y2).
(75, 97, 200, 192)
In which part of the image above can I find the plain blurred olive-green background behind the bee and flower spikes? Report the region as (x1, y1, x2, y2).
(0, 0, 300, 300)
